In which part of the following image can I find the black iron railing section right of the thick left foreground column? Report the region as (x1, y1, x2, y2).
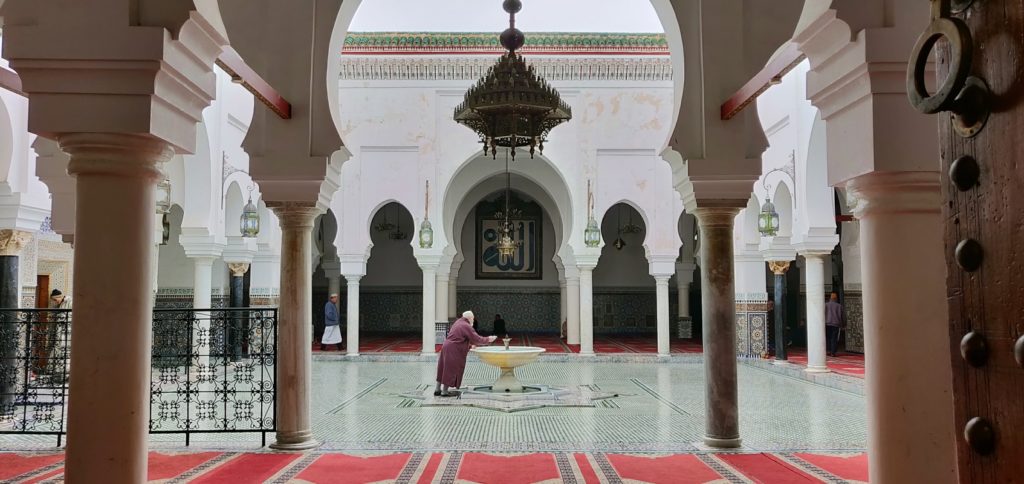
(150, 308, 278, 445)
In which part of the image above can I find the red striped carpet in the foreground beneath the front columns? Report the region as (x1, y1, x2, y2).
(0, 451, 867, 484)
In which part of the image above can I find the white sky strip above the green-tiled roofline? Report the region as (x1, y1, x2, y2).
(349, 0, 665, 34)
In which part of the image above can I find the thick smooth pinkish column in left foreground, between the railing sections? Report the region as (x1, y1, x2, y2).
(58, 133, 173, 482)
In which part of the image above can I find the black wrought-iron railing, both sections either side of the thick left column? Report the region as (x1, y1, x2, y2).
(0, 308, 278, 446)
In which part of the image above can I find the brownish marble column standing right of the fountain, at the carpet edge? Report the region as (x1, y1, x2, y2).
(694, 208, 741, 447)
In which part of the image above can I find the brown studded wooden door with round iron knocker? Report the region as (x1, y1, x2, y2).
(908, 0, 1024, 483)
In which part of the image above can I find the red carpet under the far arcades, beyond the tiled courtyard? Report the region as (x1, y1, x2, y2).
(313, 333, 864, 379)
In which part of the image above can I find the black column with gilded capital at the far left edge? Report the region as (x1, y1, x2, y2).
(0, 229, 32, 413)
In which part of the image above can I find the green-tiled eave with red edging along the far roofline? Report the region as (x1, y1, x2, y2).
(341, 32, 669, 55)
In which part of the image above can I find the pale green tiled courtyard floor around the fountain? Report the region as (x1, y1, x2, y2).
(0, 356, 866, 452)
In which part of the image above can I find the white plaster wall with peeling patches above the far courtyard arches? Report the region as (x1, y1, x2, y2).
(332, 68, 681, 278)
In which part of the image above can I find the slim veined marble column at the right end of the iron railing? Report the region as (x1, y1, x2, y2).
(267, 202, 319, 450)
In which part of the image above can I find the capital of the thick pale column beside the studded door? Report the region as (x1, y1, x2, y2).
(846, 171, 942, 219)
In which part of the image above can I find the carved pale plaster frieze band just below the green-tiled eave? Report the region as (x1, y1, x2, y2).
(340, 55, 672, 82)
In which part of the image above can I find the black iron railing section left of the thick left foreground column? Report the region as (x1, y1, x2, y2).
(0, 309, 71, 446)
